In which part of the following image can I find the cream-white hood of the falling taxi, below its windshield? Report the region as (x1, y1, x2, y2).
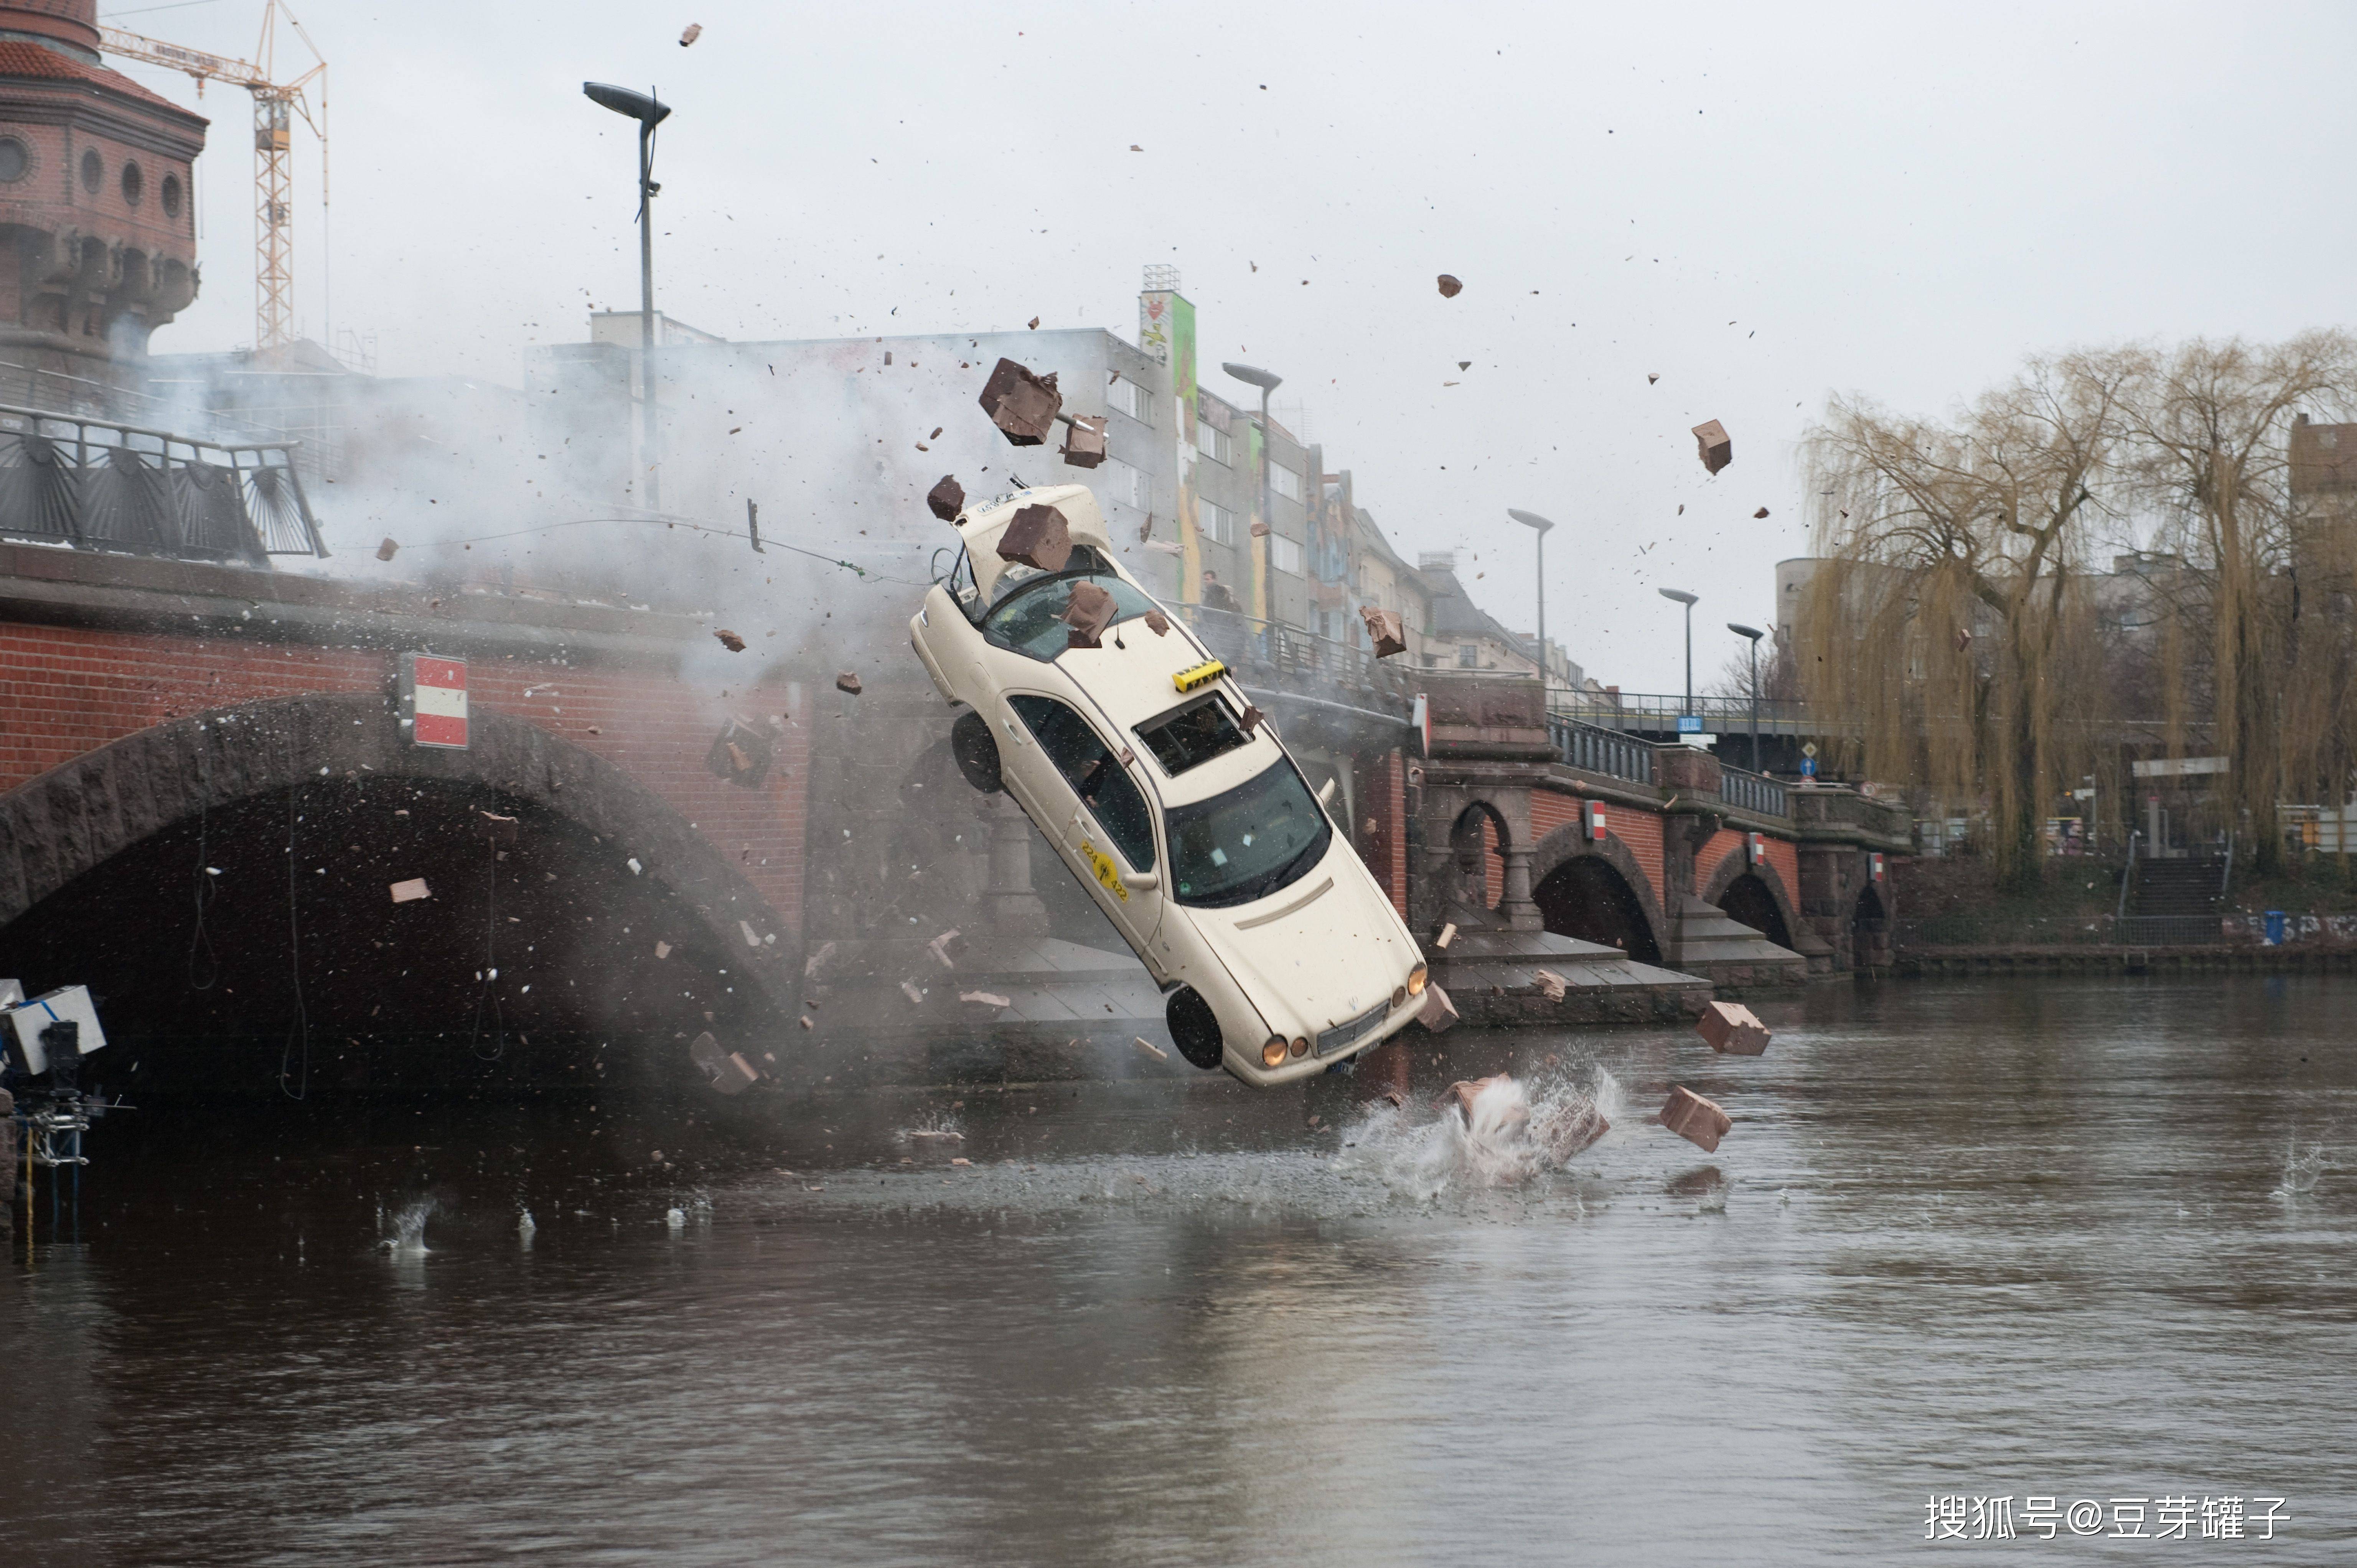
(1188, 835, 1421, 1042)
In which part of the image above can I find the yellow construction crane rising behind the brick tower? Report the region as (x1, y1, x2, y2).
(99, 0, 328, 349)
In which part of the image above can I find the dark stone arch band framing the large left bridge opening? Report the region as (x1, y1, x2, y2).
(0, 693, 799, 1009)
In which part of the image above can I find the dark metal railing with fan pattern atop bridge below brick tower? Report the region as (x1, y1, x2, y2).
(0, 403, 328, 566)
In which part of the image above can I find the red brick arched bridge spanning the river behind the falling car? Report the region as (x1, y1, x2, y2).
(0, 545, 1907, 1094)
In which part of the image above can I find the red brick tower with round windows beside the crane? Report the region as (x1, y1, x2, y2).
(0, 0, 205, 417)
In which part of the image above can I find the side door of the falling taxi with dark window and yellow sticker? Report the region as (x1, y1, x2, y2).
(1006, 693, 1162, 962)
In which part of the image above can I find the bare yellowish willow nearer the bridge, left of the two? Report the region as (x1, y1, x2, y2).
(1796, 351, 2143, 884)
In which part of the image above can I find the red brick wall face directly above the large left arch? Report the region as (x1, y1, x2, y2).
(0, 625, 813, 941)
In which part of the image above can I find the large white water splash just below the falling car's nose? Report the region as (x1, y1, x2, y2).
(1337, 1068, 1622, 1202)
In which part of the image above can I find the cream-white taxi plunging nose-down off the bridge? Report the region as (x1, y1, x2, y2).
(910, 486, 1424, 1085)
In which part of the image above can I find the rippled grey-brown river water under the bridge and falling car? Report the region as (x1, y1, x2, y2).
(0, 978, 2357, 1563)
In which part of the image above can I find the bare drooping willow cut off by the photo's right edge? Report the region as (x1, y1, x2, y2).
(2126, 330, 2357, 870)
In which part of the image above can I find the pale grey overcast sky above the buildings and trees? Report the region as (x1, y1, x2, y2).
(101, 0, 2357, 691)
